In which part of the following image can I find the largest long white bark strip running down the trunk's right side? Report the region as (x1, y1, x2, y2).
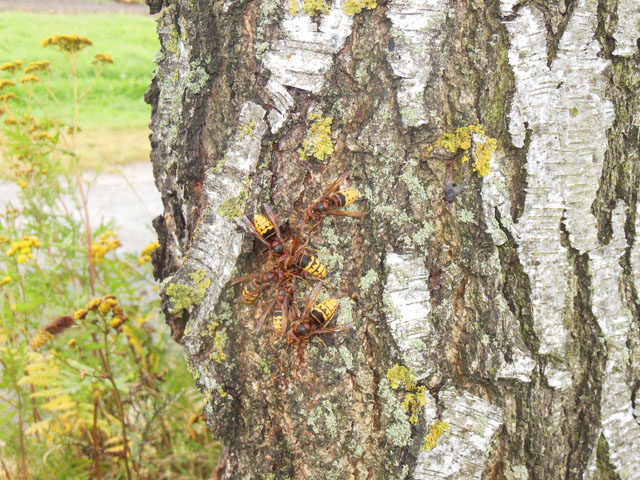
(502, 0, 613, 388)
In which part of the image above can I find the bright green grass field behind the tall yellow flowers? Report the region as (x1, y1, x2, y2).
(0, 12, 159, 129)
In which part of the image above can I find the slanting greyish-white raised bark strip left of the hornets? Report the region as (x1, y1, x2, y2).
(185, 102, 267, 355)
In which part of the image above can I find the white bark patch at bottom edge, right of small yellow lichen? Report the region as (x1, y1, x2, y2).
(414, 387, 504, 480)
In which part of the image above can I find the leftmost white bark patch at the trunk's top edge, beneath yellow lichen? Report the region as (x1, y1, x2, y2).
(263, 0, 353, 93)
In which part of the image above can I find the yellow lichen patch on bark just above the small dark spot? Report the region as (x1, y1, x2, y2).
(425, 125, 498, 178)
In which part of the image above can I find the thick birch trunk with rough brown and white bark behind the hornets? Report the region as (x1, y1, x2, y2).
(147, 0, 640, 480)
